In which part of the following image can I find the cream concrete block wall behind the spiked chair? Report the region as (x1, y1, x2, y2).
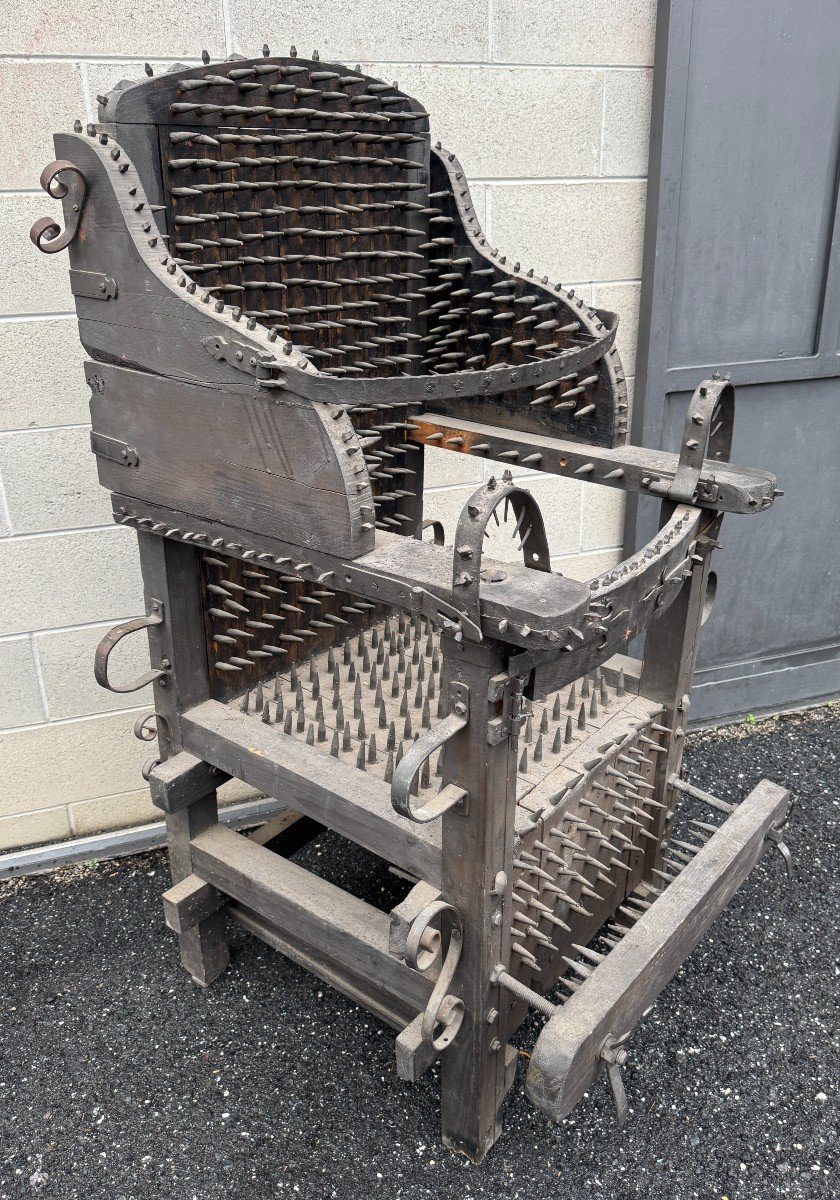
(0, 0, 655, 850)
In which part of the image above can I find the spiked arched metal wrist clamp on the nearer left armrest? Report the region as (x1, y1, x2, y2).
(452, 470, 551, 629)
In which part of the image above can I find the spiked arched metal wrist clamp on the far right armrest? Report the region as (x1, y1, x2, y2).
(649, 379, 734, 504)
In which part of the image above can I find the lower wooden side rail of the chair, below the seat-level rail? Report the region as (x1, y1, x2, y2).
(192, 826, 431, 1015)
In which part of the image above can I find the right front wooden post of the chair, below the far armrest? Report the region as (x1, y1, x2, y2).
(640, 500, 722, 881)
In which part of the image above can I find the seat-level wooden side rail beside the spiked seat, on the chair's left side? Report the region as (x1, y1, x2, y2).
(182, 700, 440, 884)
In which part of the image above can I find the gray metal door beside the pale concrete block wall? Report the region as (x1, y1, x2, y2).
(626, 0, 840, 721)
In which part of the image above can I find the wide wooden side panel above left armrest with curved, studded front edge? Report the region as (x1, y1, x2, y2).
(88, 362, 373, 558)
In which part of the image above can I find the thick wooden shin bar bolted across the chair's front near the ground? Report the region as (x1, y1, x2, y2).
(526, 779, 790, 1121)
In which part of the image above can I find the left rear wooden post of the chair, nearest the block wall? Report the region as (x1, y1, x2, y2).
(138, 533, 229, 986)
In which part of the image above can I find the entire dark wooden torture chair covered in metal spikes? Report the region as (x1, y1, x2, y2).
(32, 48, 788, 1160)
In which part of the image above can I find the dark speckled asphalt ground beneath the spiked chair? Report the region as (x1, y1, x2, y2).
(0, 706, 840, 1200)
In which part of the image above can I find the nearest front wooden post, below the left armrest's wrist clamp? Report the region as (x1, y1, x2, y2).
(440, 637, 517, 1162)
